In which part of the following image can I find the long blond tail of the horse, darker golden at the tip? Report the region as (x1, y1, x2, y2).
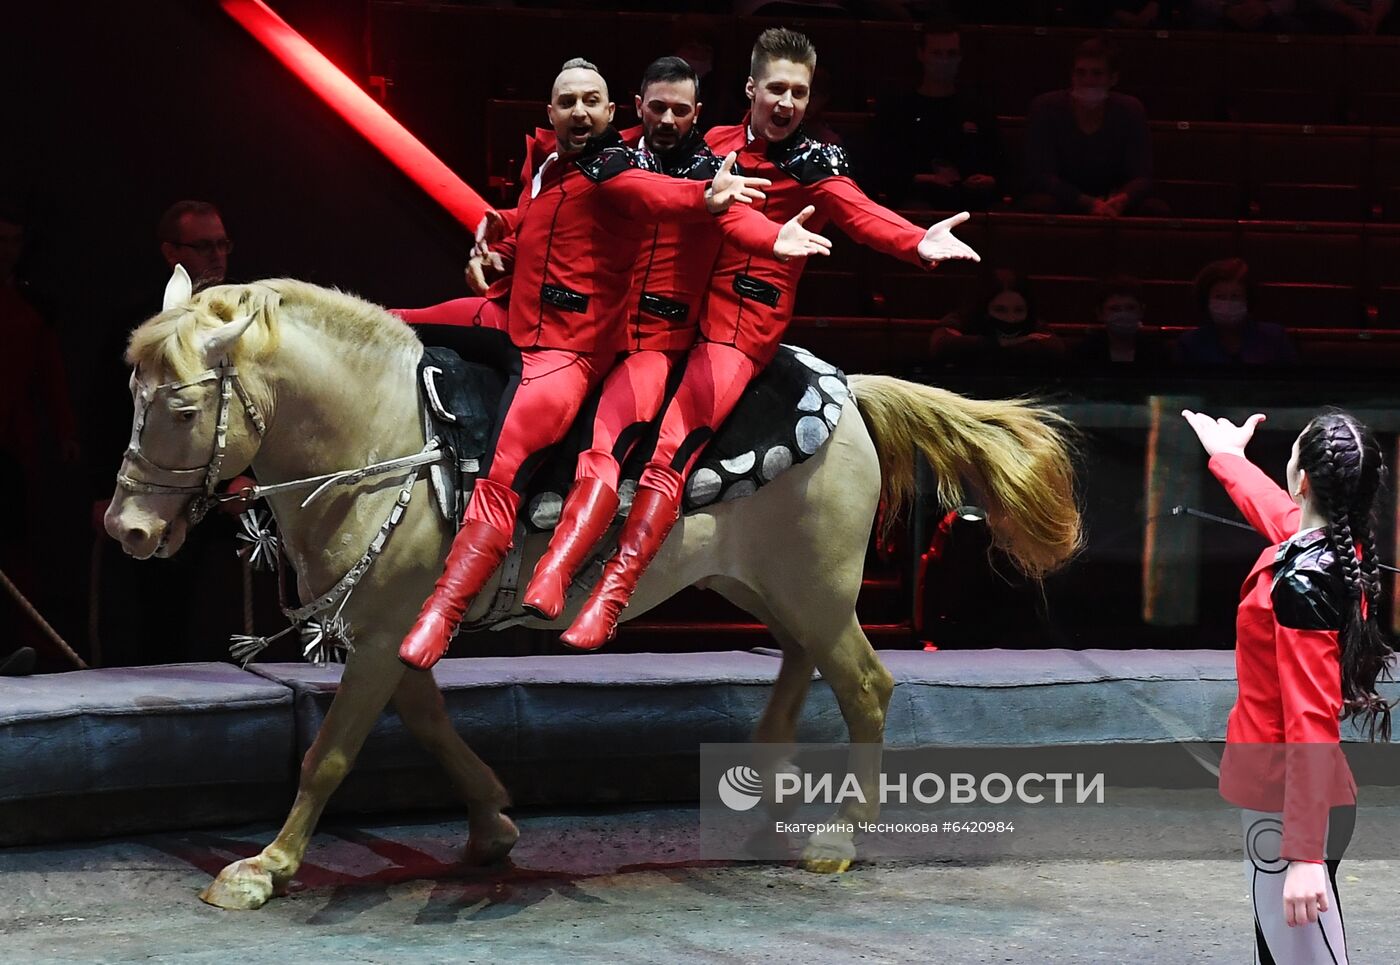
(850, 375, 1082, 578)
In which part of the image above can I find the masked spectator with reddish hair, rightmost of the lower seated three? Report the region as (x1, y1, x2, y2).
(1177, 258, 1298, 367)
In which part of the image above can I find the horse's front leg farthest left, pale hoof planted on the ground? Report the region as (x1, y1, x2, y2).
(199, 639, 403, 910)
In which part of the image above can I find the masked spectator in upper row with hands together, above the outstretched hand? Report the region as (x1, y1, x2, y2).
(1022, 39, 1168, 217)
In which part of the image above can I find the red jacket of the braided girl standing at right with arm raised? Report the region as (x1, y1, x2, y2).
(1210, 454, 1357, 861)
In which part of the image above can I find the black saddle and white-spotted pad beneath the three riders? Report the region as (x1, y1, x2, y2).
(414, 325, 850, 532)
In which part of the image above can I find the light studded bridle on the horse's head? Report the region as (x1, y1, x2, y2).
(116, 361, 267, 527)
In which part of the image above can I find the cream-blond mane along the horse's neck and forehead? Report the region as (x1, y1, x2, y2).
(126, 279, 420, 380)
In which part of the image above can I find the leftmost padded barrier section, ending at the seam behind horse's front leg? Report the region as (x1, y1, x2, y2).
(0, 664, 295, 845)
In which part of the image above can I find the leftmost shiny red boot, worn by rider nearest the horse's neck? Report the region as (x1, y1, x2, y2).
(399, 479, 519, 669)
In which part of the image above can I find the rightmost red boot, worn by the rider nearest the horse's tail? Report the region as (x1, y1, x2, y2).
(560, 471, 680, 650)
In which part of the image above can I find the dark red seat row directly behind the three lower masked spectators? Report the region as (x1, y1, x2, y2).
(797, 211, 1400, 329)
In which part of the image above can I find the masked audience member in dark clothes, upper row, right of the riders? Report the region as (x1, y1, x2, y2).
(875, 21, 1001, 211)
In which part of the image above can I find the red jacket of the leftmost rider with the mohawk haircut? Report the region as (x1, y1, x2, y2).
(490, 129, 778, 353)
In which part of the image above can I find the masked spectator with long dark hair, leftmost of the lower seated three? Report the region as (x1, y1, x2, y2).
(928, 269, 1064, 366)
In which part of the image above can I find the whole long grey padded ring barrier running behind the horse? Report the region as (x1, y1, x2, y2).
(0, 650, 1400, 845)
